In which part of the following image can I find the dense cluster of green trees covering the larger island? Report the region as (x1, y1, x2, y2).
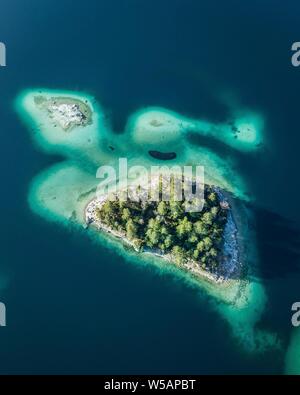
(97, 186, 227, 270)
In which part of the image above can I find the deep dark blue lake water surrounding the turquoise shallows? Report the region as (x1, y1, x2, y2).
(0, 0, 300, 374)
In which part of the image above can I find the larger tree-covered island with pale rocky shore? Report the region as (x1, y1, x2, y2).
(86, 178, 238, 282)
